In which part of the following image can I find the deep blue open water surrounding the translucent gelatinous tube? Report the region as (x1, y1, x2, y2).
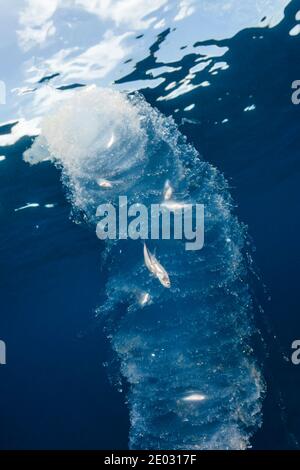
(0, 0, 300, 449)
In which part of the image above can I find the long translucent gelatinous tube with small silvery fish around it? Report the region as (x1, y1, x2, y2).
(23, 87, 263, 450)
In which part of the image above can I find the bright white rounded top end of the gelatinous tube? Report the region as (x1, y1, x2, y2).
(24, 86, 146, 216)
